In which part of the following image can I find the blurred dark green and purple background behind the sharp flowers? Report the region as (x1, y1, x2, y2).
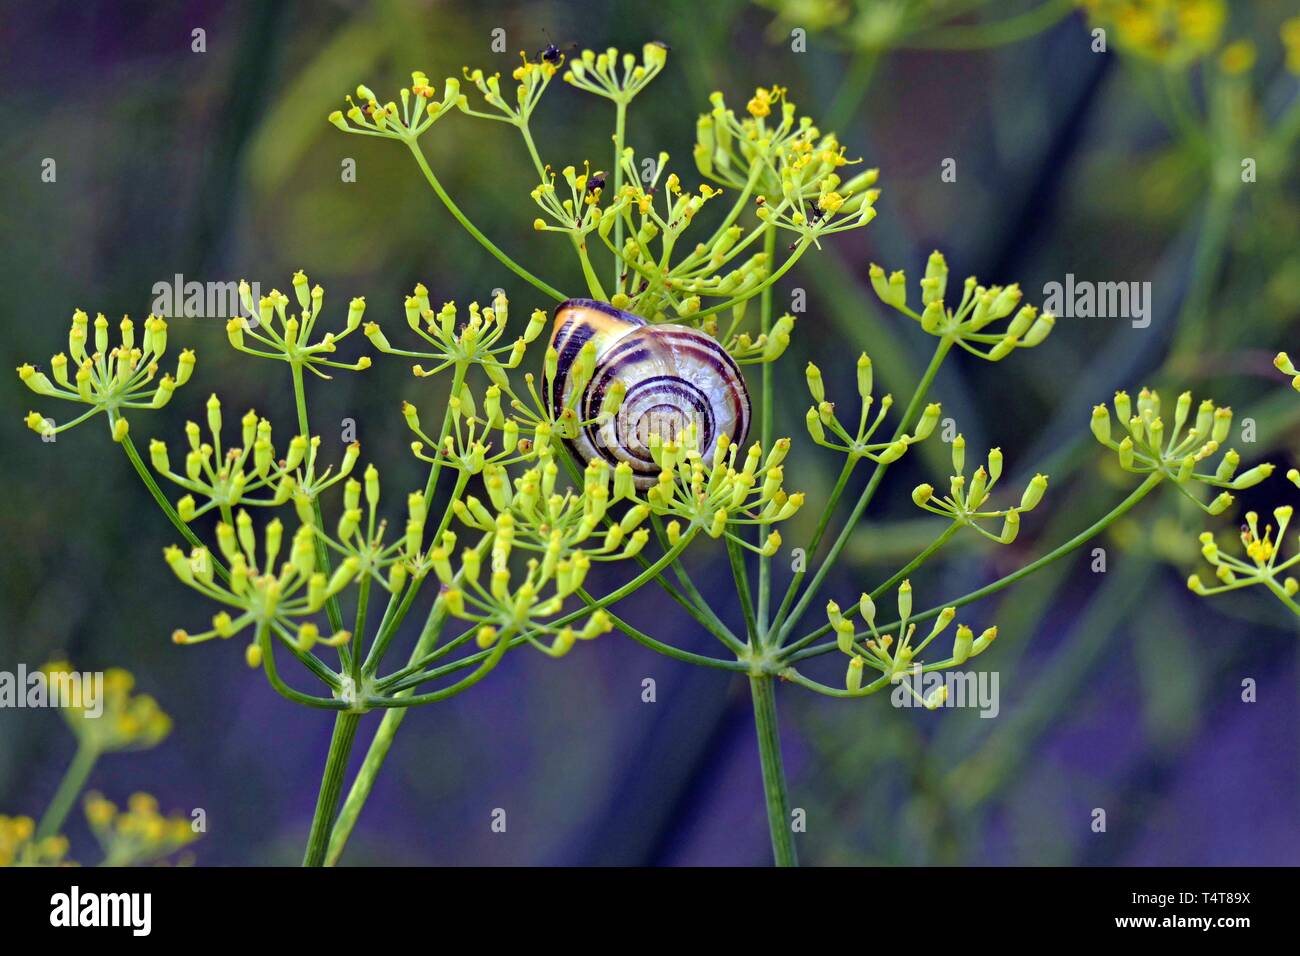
(0, 0, 1300, 864)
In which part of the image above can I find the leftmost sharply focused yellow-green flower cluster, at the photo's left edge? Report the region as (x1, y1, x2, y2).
(18, 310, 194, 441)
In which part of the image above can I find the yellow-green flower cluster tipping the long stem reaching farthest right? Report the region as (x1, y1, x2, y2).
(1092, 389, 1273, 515)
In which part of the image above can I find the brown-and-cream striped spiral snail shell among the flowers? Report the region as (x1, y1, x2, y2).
(550, 299, 750, 490)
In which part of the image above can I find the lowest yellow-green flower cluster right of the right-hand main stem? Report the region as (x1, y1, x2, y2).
(826, 580, 997, 708)
